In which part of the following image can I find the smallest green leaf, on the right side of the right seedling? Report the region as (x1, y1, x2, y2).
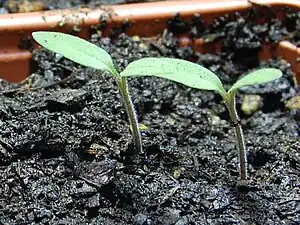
(228, 68, 282, 92)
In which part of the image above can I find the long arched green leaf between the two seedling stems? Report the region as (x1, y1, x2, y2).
(120, 57, 226, 96)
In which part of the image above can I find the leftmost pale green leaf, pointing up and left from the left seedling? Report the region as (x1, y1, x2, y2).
(32, 31, 118, 76)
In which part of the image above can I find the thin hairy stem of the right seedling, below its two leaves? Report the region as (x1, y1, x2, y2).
(226, 94, 247, 181)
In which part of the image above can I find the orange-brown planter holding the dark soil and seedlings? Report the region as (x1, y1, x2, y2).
(0, 0, 299, 82)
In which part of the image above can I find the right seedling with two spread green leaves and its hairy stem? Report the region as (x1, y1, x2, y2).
(120, 57, 282, 183)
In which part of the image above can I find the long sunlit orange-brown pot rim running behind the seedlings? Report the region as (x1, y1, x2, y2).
(0, 0, 251, 33)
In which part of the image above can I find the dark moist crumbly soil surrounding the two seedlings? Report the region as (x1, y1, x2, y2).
(0, 9, 300, 225)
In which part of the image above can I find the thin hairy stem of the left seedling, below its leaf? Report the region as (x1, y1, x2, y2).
(118, 77, 143, 153)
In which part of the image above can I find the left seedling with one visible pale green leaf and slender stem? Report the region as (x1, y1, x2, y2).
(32, 31, 143, 153)
